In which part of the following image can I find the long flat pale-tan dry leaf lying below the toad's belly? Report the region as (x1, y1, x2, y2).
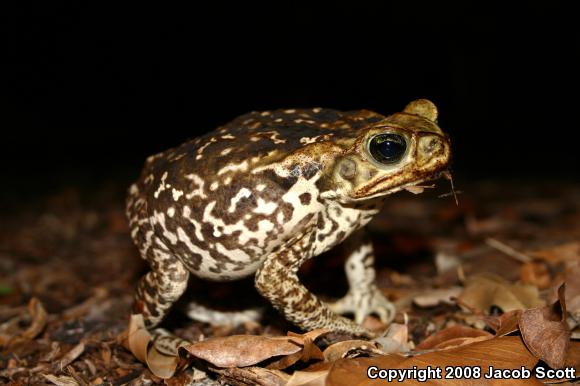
(182, 335, 302, 367)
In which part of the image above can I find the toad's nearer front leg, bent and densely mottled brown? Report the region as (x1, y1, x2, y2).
(255, 232, 373, 338)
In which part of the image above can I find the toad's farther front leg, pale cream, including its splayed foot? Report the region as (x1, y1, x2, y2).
(328, 229, 395, 323)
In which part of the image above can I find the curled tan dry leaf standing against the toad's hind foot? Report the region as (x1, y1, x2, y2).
(117, 314, 179, 379)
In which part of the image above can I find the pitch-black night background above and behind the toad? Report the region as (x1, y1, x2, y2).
(0, 1, 580, 199)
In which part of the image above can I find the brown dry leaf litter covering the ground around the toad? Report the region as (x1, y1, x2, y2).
(0, 180, 580, 386)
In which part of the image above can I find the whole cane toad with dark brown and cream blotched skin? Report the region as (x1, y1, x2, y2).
(127, 99, 450, 337)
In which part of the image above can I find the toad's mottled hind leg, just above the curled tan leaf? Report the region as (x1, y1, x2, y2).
(133, 241, 189, 328)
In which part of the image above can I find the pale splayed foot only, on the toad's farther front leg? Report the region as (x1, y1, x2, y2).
(328, 286, 396, 324)
